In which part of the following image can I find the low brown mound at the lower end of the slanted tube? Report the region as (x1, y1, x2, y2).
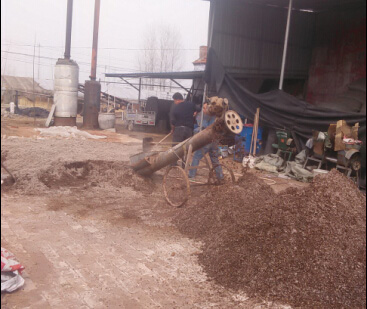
(9, 160, 155, 194)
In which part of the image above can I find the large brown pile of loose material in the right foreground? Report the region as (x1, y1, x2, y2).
(175, 170, 366, 308)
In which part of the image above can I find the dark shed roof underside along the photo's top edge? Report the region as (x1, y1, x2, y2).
(207, 0, 366, 11)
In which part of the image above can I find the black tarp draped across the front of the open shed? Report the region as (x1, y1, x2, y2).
(204, 48, 366, 156)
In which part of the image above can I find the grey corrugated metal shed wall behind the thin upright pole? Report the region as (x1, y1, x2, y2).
(211, 0, 315, 78)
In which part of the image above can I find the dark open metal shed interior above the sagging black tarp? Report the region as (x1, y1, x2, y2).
(208, 0, 366, 101)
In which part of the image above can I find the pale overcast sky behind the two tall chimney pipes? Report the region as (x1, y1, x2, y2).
(1, 0, 209, 97)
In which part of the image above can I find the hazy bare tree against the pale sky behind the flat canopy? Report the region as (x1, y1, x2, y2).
(138, 25, 183, 90)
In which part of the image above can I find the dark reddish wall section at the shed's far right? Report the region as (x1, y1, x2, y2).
(307, 8, 366, 104)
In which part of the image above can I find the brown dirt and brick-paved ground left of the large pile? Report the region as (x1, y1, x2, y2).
(1, 113, 303, 309)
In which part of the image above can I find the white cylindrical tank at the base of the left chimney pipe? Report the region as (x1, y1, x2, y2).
(54, 59, 79, 118)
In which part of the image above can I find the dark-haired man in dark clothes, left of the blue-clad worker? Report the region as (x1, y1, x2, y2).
(171, 92, 196, 145)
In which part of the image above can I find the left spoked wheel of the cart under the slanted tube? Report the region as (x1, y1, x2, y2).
(163, 166, 191, 207)
